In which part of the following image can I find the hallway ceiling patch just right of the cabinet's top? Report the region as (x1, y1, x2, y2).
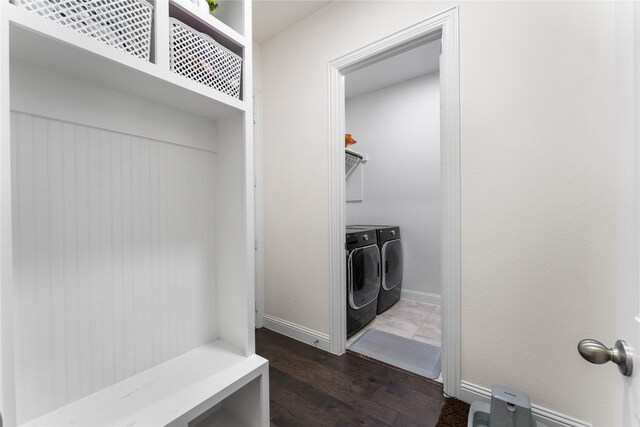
(253, 0, 330, 43)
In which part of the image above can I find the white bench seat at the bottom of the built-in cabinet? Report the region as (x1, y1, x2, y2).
(23, 340, 268, 427)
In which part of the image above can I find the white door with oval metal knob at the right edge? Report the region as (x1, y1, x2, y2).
(608, 2, 640, 427)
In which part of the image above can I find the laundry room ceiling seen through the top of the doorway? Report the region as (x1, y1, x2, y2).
(345, 39, 441, 98)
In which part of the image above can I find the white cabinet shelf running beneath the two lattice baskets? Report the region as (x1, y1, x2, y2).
(6, 2, 245, 119)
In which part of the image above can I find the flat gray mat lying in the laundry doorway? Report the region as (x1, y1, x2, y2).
(348, 328, 441, 378)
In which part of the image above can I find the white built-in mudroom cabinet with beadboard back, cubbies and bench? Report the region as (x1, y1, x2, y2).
(0, 0, 268, 427)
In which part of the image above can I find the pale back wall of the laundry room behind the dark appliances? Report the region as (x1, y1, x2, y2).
(345, 73, 441, 295)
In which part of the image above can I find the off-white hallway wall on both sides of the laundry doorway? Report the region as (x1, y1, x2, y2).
(262, 1, 616, 426)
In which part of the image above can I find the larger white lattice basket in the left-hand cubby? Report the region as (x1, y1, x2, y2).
(13, 0, 153, 61)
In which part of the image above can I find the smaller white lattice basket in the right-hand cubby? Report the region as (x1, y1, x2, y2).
(169, 18, 242, 98)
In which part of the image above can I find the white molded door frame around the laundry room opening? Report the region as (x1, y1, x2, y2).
(329, 7, 460, 397)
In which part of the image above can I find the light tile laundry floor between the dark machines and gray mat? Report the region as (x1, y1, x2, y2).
(347, 299, 441, 347)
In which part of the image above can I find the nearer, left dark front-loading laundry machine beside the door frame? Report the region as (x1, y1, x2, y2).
(346, 228, 381, 337)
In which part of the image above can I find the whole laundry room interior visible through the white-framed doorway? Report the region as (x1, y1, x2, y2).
(345, 39, 442, 378)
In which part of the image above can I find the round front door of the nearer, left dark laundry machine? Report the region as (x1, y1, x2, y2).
(347, 245, 380, 310)
